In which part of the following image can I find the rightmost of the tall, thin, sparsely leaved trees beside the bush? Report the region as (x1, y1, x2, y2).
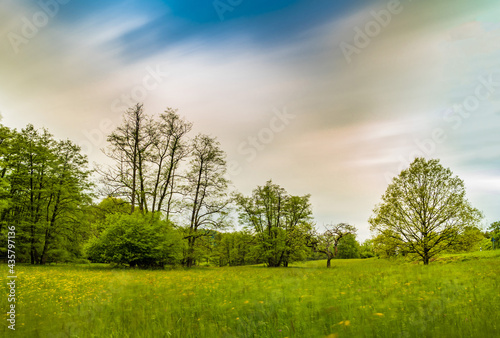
(182, 134, 230, 267)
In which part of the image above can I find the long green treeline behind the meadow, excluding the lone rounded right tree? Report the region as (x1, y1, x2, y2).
(0, 104, 498, 267)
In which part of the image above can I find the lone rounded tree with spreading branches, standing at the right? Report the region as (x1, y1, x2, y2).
(369, 158, 482, 265)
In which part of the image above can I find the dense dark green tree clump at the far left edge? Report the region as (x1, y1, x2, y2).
(0, 125, 91, 264)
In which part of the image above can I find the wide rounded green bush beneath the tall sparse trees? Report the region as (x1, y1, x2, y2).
(86, 212, 182, 268)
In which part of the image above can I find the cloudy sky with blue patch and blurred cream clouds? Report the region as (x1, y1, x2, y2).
(0, 0, 500, 240)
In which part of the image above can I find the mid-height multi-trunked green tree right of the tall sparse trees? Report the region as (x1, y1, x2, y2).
(236, 181, 312, 267)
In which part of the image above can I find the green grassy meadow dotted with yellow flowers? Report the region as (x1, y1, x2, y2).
(0, 250, 500, 338)
